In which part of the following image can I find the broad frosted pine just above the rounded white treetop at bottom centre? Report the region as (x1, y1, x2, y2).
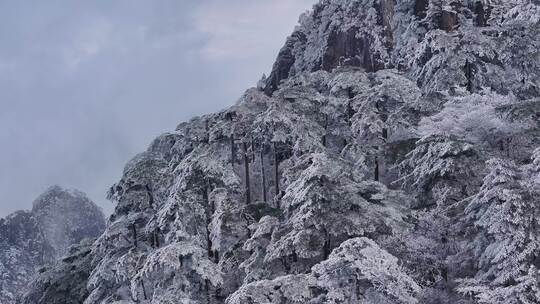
(243, 154, 412, 277)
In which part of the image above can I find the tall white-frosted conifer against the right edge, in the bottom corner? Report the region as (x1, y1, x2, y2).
(460, 159, 540, 303)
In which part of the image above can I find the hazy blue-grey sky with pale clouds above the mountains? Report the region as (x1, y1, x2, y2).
(0, 0, 315, 217)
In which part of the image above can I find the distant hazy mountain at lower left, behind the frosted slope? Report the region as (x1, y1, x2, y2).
(0, 186, 105, 304)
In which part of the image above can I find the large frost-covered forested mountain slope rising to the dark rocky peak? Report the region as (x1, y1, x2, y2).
(19, 0, 540, 304)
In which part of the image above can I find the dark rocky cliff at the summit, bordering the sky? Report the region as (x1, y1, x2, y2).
(264, 0, 396, 95)
